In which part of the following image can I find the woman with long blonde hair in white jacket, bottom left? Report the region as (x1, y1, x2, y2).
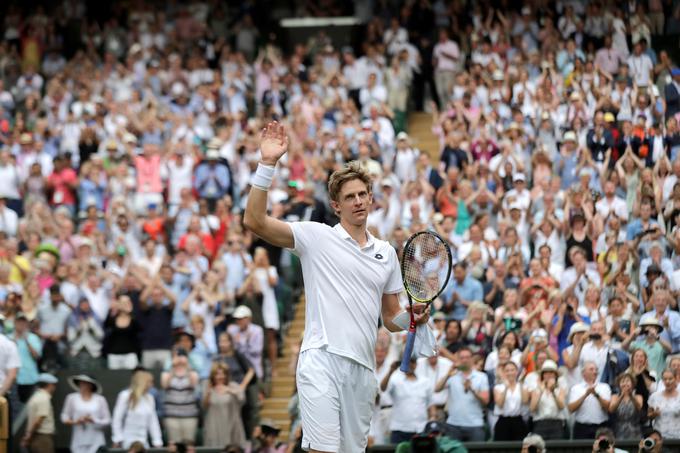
(111, 370, 163, 448)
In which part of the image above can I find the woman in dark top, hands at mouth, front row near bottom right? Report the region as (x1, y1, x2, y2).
(609, 373, 642, 439)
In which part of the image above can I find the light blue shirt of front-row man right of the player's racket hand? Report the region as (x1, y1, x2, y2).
(446, 371, 489, 428)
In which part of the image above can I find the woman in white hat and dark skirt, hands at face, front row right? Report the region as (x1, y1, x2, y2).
(529, 360, 567, 440)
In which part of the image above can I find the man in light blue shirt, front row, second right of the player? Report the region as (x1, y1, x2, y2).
(434, 347, 489, 442)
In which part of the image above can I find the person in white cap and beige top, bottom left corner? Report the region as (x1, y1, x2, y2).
(21, 373, 59, 453)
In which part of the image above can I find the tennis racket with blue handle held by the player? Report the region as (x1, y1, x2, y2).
(400, 231, 452, 373)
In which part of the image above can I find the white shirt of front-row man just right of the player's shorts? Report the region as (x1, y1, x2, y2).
(387, 371, 432, 433)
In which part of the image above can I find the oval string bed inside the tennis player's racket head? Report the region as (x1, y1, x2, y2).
(402, 234, 448, 301)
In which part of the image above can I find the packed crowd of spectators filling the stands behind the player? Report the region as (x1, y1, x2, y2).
(0, 0, 680, 452)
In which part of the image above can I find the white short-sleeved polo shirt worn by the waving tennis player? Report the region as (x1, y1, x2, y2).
(289, 222, 403, 370)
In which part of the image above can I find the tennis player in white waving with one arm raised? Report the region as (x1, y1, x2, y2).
(244, 122, 428, 453)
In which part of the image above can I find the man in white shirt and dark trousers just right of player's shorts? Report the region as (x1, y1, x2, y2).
(380, 357, 435, 444)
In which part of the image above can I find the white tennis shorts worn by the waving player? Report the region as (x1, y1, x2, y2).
(297, 349, 378, 453)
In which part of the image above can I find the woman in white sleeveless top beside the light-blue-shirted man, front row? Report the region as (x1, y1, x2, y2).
(493, 361, 527, 440)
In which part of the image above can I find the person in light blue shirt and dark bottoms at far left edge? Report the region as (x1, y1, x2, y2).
(11, 312, 42, 403)
